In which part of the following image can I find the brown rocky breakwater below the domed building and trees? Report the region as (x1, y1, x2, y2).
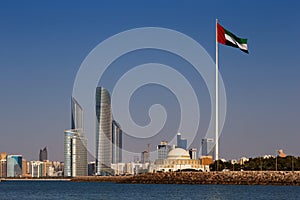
(116, 171, 300, 186)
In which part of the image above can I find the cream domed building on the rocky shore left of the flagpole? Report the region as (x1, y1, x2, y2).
(154, 148, 203, 172)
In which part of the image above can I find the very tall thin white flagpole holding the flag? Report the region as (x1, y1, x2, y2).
(215, 19, 219, 160)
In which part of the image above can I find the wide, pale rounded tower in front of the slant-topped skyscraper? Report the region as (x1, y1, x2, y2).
(64, 130, 88, 177)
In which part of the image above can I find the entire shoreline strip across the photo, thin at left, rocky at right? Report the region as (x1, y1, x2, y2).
(0, 171, 300, 186)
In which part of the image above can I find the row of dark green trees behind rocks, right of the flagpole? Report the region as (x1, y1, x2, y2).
(210, 156, 300, 171)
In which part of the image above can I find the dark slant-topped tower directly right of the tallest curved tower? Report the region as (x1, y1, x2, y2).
(112, 120, 122, 163)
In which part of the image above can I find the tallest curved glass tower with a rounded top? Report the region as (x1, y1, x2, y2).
(96, 87, 112, 175)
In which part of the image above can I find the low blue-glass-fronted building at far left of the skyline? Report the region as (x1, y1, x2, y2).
(6, 155, 22, 177)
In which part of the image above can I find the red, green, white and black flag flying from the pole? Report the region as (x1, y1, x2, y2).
(217, 23, 249, 53)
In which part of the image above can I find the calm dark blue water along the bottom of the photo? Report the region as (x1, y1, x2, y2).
(0, 181, 300, 200)
